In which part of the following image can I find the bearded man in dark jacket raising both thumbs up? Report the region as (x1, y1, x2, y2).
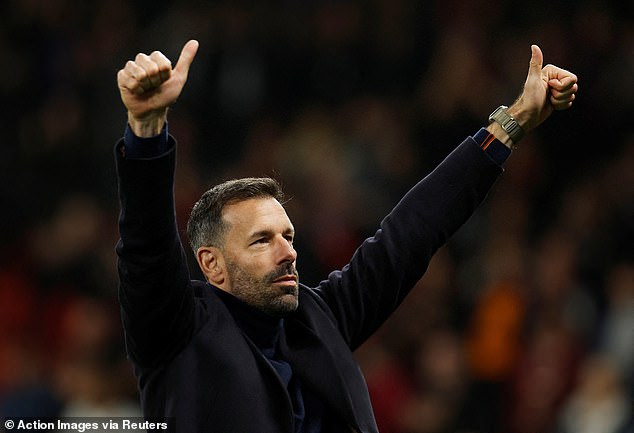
(115, 41, 577, 433)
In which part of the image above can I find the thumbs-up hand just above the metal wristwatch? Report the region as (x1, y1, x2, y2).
(509, 45, 579, 131)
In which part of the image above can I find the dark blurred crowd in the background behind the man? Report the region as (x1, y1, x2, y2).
(0, 0, 634, 433)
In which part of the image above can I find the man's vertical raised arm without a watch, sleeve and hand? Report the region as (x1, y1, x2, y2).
(115, 41, 198, 368)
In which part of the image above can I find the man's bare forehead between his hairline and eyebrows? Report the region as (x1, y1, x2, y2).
(222, 197, 293, 235)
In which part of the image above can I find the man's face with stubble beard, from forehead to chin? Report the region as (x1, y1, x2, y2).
(222, 198, 298, 316)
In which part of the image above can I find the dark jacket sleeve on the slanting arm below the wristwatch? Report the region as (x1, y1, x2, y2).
(316, 137, 502, 350)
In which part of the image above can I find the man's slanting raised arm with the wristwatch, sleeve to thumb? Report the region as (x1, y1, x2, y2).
(317, 45, 578, 349)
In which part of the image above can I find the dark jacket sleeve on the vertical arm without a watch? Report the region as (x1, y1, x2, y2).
(115, 136, 194, 368)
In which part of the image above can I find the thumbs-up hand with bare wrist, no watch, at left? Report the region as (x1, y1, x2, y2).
(117, 40, 198, 137)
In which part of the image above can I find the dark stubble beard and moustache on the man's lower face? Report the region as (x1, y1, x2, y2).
(226, 260, 299, 317)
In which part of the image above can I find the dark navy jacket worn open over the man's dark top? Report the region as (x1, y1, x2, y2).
(116, 136, 502, 433)
